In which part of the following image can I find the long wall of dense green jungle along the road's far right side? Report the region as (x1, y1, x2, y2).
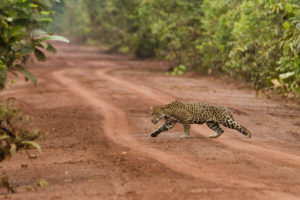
(52, 0, 300, 98)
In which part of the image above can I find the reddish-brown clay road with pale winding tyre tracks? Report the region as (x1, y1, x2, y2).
(0, 45, 300, 200)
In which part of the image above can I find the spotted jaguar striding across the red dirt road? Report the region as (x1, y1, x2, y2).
(151, 100, 251, 138)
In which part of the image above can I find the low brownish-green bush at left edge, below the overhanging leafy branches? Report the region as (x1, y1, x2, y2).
(0, 99, 41, 162)
